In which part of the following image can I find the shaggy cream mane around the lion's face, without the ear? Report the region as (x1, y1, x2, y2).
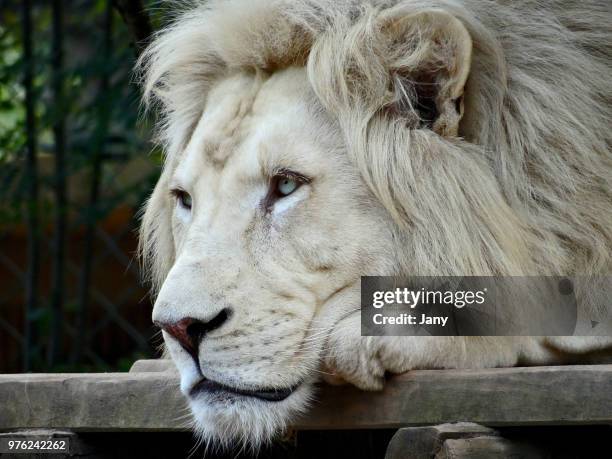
(141, 0, 612, 285)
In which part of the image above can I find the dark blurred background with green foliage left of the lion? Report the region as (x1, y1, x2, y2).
(0, 0, 166, 373)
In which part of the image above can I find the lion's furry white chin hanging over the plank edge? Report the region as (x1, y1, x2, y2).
(188, 382, 313, 449)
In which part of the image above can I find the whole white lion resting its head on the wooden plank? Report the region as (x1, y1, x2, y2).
(140, 0, 612, 450)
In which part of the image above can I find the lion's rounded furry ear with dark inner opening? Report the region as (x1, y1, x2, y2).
(379, 9, 472, 137)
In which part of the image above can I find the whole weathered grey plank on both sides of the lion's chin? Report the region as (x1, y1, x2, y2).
(0, 365, 612, 431)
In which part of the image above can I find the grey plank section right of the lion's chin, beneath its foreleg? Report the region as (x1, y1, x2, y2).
(297, 365, 612, 428)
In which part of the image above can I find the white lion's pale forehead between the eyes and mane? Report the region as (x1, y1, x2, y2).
(174, 68, 339, 191)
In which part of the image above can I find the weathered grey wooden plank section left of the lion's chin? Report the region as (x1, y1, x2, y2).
(0, 373, 189, 431)
